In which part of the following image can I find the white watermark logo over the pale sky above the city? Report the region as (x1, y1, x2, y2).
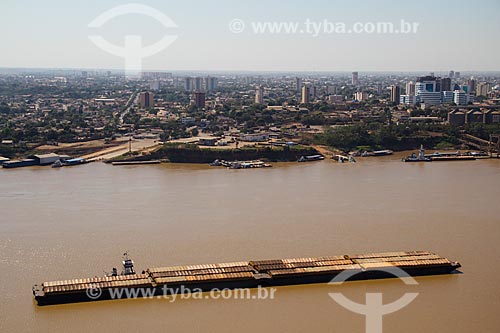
(88, 4, 178, 76)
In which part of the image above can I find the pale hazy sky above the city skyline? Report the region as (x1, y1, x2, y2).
(0, 0, 500, 71)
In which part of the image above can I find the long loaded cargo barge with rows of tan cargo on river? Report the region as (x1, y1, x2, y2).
(33, 251, 461, 305)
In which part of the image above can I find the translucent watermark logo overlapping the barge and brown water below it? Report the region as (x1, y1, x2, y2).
(329, 267, 418, 333)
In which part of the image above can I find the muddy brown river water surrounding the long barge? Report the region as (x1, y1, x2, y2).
(0, 155, 500, 333)
